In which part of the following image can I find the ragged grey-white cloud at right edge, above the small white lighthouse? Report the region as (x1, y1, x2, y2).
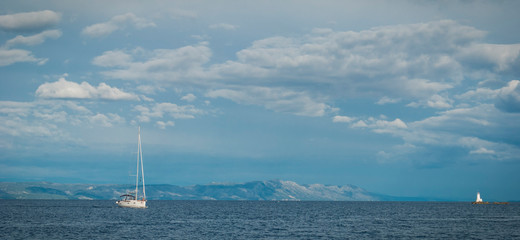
(333, 101, 520, 162)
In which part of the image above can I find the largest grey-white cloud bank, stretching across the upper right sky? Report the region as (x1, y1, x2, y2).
(223, 20, 484, 78)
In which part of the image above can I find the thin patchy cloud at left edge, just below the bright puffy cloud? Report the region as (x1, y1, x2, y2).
(0, 99, 132, 145)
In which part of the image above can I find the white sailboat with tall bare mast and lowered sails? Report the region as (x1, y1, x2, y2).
(116, 126, 146, 208)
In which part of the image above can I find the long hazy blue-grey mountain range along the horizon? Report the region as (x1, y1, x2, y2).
(0, 180, 414, 201)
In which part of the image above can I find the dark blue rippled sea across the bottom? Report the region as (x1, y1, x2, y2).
(0, 200, 520, 240)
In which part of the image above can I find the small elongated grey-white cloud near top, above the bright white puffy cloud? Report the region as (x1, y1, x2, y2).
(81, 13, 156, 37)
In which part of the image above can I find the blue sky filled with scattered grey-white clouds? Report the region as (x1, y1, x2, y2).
(0, 0, 520, 201)
